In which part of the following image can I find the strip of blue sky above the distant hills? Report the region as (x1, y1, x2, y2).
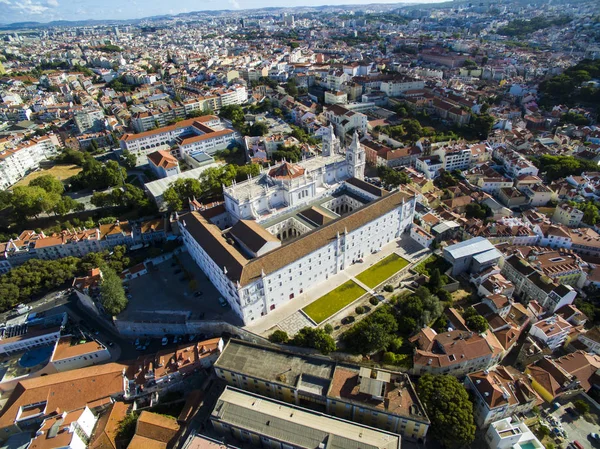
(0, 0, 439, 23)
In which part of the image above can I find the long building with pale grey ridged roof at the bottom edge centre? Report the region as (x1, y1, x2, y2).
(210, 387, 401, 449)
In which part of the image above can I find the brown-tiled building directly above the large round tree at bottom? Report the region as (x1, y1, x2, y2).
(410, 327, 504, 377)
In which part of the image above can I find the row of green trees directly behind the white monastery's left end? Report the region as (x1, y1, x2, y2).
(163, 164, 260, 210)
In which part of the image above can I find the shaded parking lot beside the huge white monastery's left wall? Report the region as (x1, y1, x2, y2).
(119, 253, 242, 325)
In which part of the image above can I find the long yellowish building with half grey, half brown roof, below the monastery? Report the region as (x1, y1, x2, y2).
(214, 340, 430, 442)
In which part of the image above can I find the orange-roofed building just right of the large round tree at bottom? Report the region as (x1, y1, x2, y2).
(465, 366, 543, 429)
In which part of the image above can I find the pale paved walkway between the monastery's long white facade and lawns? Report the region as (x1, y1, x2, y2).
(245, 236, 429, 335)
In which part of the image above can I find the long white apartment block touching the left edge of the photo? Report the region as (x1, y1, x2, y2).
(0, 136, 56, 190)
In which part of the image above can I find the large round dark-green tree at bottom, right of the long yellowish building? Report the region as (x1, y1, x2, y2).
(417, 374, 475, 448)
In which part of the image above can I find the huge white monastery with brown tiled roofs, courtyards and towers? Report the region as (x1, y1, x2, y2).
(180, 134, 415, 324)
